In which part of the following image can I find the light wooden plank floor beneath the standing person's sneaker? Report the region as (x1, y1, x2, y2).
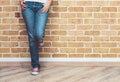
(0, 66, 120, 82)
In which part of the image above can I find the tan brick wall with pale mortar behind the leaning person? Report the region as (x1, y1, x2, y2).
(0, 0, 120, 58)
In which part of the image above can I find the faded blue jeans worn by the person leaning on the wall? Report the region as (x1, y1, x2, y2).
(22, 1, 48, 68)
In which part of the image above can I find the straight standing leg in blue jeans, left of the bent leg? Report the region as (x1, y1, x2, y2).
(22, 8, 40, 68)
